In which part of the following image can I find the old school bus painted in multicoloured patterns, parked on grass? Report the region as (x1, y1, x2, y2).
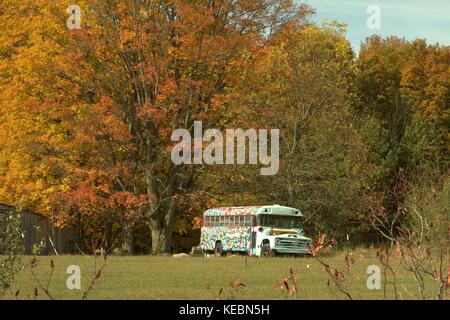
(200, 205, 312, 257)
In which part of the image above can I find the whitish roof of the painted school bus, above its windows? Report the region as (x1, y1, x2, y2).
(205, 204, 303, 217)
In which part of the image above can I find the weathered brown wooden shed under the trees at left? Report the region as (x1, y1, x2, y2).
(0, 204, 79, 255)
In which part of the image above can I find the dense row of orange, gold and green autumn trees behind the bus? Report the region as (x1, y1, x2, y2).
(0, 0, 450, 254)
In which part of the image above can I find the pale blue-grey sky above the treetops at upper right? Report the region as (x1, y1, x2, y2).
(304, 0, 450, 52)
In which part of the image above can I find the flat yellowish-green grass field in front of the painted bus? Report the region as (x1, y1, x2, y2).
(6, 249, 437, 299)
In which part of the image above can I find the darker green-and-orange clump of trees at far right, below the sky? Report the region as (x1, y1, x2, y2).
(356, 36, 450, 239)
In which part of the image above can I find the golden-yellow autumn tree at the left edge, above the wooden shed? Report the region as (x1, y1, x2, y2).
(0, 1, 76, 214)
